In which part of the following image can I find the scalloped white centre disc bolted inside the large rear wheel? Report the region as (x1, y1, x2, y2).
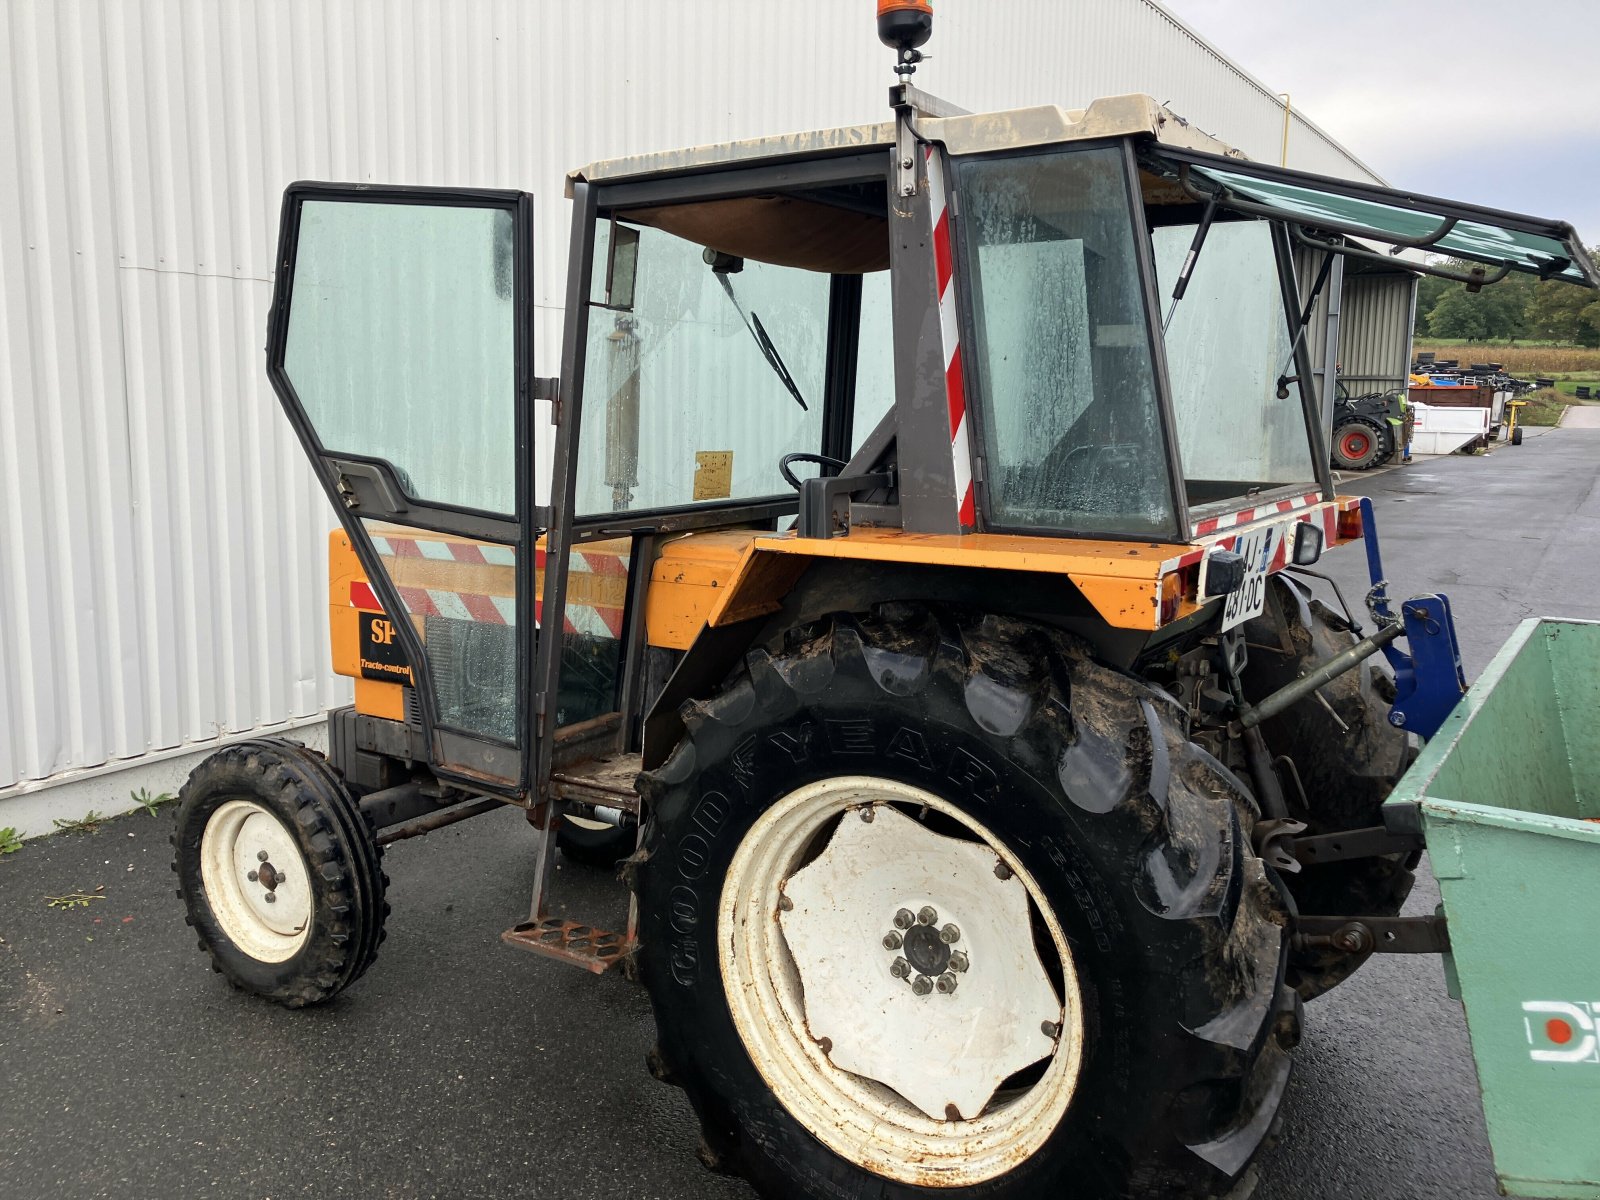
(778, 805, 1062, 1120)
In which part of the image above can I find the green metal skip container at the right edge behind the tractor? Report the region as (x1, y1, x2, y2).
(1389, 618, 1600, 1200)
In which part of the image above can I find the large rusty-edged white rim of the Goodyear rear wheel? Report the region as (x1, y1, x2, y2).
(717, 776, 1083, 1187)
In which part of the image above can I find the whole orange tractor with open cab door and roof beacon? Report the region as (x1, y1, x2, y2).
(176, 0, 1594, 1197)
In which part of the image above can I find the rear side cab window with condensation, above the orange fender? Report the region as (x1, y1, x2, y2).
(957, 146, 1176, 538)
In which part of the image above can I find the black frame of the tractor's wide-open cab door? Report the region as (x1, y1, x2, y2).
(266, 181, 549, 803)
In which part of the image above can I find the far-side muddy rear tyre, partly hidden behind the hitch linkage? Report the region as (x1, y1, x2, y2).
(1242, 574, 1418, 1000)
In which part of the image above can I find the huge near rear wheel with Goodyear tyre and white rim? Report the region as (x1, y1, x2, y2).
(634, 605, 1299, 1200)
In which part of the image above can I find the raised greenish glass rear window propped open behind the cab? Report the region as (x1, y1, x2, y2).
(1152, 147, 1600, 288)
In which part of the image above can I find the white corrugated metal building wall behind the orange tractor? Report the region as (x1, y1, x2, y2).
(0, 0, 1370, 824)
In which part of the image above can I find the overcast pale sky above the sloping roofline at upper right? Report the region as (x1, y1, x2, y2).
(1162, 0, 1600, 246)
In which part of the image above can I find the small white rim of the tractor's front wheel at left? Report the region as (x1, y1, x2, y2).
(200, 800, 312, 963)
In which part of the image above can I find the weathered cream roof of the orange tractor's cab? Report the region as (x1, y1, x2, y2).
(566, 94, 1245, 195)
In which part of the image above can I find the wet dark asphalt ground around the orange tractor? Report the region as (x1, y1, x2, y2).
(9, 429, 1600, 1200)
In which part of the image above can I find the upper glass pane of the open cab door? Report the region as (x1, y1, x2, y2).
(283, 200, 517, 514)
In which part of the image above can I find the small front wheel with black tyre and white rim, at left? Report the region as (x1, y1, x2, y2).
(173, 739, 389, 1008)
